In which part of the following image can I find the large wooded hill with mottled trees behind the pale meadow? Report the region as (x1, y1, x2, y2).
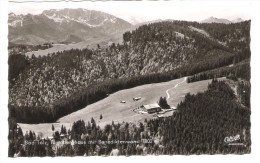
(9, 21, 250, 123)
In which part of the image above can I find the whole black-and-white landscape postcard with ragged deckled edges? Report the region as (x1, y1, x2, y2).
(1, 1, 259, 160)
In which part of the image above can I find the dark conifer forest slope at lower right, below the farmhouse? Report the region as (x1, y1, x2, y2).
(145, 80, 251, 154)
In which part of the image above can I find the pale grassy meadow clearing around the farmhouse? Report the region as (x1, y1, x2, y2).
(19, 78, 224, 136)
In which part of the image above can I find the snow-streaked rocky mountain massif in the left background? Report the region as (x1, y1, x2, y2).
(8, 9, 132, 45)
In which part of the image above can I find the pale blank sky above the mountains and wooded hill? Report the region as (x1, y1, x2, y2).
(8, 0, 252, 23)
